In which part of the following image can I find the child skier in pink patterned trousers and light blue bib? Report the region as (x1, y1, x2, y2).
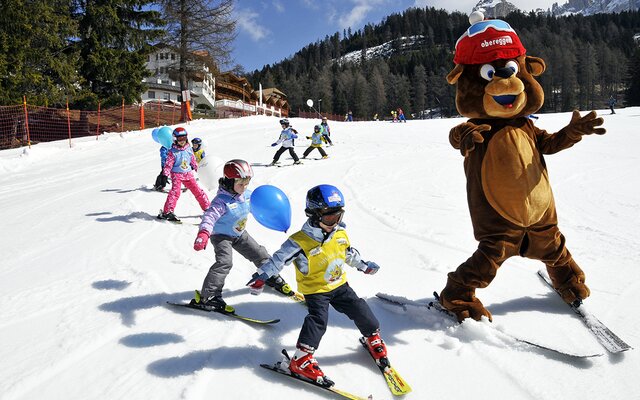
(158, 127, 209, 222)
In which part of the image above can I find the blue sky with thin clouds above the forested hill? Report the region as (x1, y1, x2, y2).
(233, 0, 565, 72)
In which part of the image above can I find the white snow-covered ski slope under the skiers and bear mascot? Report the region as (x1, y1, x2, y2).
(0, 108, 640, 400)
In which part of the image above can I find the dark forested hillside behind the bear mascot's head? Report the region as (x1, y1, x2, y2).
(249, 8, 640, 119)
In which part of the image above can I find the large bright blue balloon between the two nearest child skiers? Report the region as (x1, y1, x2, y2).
(251, 185, 291, 232)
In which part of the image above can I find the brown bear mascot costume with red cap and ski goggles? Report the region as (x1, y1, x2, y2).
(440, 11, 605, 321)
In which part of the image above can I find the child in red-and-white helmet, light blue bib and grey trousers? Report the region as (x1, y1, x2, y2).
(191, 160, 295, 312)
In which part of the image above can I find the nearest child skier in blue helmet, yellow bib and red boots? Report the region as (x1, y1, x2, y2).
(247, 185, 389, 386)
